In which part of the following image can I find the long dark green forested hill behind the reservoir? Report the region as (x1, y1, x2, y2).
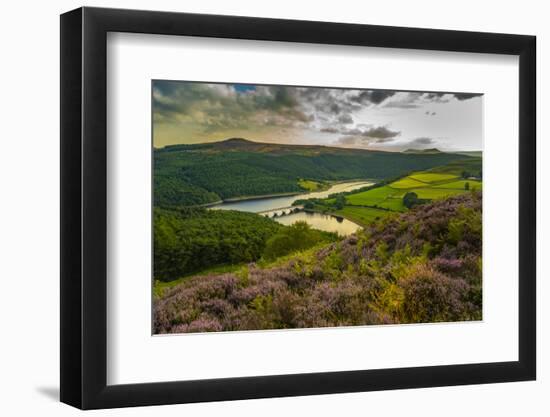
(154, 138, 474, 207)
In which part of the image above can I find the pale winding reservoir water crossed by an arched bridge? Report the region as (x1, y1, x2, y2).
(211, 181, 373, 236)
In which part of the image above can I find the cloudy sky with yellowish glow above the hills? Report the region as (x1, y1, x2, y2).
(152, 80, 482, 151)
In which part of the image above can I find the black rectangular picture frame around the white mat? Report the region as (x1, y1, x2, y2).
(60, 7, 536, 409)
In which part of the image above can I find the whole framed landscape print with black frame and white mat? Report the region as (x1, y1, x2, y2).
(61, 8, 536, 409)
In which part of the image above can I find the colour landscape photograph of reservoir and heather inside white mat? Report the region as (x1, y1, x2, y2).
(151, 80, 483, 334)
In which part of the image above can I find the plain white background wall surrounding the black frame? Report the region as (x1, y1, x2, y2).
(0, 0, 550, 417)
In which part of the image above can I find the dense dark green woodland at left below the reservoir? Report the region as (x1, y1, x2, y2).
(154, 208, 283, 281)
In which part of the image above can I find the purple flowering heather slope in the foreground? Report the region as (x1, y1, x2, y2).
(154, 193, 482, 333)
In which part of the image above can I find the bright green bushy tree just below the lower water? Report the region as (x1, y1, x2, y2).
(264, 222, 338, 261)
